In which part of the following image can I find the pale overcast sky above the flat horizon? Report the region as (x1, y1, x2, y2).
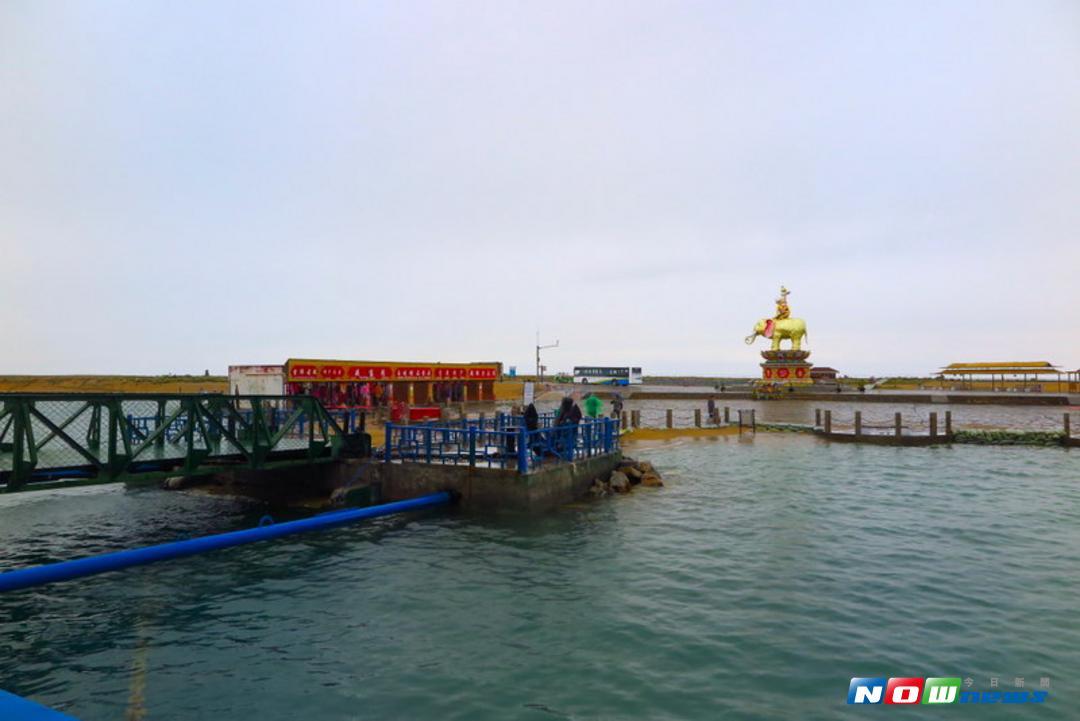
(0, 0, 1080, 376)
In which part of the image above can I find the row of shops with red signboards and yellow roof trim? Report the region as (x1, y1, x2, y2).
(229, 358, 502, 409)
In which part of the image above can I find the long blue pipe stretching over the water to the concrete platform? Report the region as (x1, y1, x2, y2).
(0, 491, 453, 593)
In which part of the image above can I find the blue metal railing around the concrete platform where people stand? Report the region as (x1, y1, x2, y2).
(383, 414, 619, 474)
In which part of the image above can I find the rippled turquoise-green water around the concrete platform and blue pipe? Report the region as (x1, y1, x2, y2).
(0, 434, 1080, 721)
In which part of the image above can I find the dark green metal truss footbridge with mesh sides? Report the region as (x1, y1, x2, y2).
(0, 394, 345, 490)
